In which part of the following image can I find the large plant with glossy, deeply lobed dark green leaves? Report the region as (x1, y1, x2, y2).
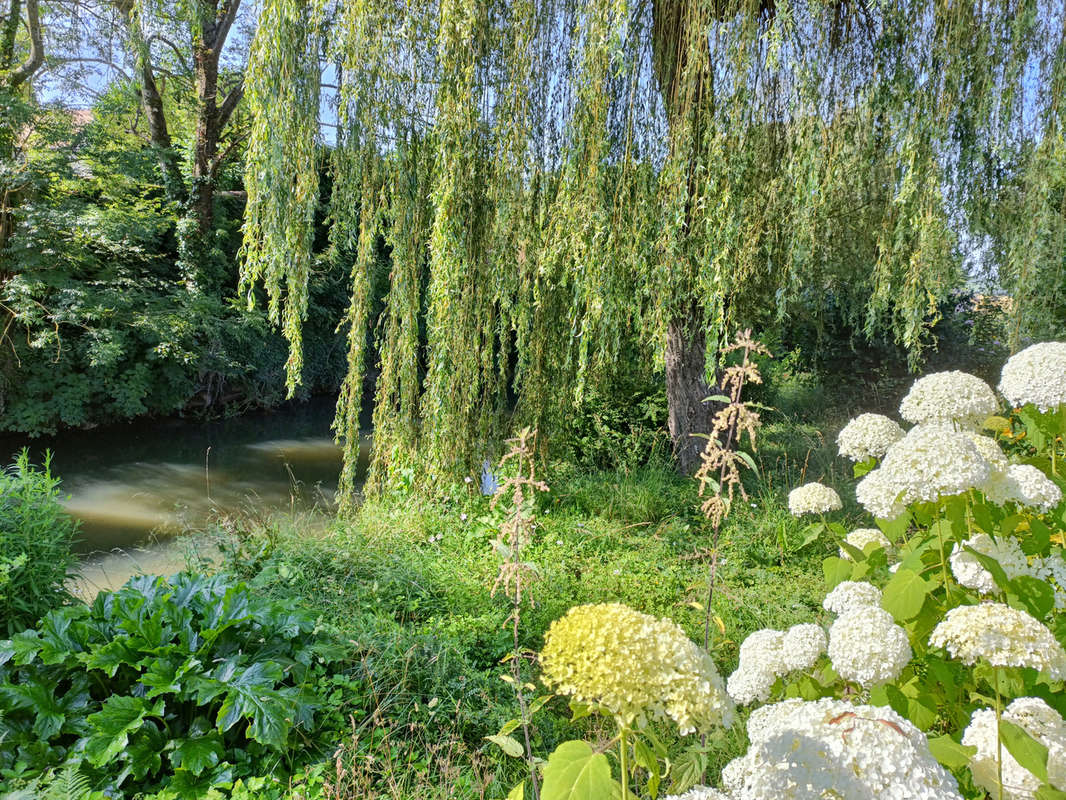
(0, 574, 338, 798)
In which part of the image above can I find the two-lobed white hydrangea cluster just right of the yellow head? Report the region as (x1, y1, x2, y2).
(726, 623, 826, 705)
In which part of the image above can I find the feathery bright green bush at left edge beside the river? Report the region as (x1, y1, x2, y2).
(0, 450, 78, 634)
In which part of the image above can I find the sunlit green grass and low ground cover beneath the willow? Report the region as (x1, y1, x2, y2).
(201, 421, 874, 797)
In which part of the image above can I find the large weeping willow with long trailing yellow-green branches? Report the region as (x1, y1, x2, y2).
(237, 0, 1066, 501)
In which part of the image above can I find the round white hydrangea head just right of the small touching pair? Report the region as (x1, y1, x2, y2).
(829, 606, 912, 688)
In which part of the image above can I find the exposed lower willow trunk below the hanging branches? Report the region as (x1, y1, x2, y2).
(666, 304, 712, 475)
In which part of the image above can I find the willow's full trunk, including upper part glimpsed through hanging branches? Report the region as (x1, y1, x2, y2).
(652, 0, 713, 474)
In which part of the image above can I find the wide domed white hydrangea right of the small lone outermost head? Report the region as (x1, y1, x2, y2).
(855, 425, 992, 518)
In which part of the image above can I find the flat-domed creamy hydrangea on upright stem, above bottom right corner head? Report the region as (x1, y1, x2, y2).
(930, 603, 1066, 681)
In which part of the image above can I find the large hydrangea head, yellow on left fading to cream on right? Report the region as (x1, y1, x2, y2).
(540, 603, 733, 734)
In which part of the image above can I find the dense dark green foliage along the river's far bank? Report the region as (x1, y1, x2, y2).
(0, 105, 344, 434)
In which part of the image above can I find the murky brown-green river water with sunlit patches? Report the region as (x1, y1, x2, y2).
(0, 398, 367, 595)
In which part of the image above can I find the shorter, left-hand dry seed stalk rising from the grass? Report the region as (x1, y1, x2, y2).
(490, 428, 548, 800)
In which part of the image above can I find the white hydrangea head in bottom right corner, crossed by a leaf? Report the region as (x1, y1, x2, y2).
(963, 698, 1066, 800)
